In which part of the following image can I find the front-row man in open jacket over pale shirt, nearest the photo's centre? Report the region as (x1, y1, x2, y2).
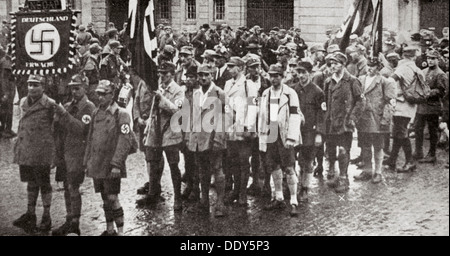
(188, 66, 226, 217)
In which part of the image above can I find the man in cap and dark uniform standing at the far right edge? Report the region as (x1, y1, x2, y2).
(415, 49, 448, 163)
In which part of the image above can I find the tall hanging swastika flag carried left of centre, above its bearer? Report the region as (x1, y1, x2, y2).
(127, 0, 158, 91)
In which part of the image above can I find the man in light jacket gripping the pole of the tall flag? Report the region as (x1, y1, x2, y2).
(137, 62, 184, 211)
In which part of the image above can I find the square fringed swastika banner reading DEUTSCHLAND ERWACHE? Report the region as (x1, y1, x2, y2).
(11, 11, 76, 75)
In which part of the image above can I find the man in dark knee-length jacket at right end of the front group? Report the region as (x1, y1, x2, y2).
(321, 52, 362, 193)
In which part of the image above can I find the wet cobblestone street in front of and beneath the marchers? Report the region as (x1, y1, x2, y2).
(0, 109, 449, 236)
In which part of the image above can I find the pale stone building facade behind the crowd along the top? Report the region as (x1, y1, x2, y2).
(0, 0, 449, 42)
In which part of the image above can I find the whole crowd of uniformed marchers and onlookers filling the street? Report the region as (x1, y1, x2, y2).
(0, 19, 449, 235)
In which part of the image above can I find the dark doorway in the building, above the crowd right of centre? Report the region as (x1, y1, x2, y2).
(247, 0, 294, 30)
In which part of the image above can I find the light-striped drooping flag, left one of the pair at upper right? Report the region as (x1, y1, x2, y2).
(336, 0, 374, 52)
